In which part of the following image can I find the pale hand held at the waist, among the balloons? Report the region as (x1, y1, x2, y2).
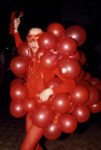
(39, 88, 53, 102)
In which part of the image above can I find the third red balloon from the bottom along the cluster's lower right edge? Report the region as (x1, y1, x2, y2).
(73, 105, 90, 123)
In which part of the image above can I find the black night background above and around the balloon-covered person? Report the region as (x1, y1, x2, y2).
(0, 0, 101, 104)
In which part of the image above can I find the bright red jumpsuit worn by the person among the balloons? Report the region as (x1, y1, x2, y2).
(14, 33, 75, 150)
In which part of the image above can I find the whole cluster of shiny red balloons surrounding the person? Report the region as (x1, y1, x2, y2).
(10, 23, 101, 139)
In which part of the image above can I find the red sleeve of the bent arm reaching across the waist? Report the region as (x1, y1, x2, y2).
(53, 69, 76, 94)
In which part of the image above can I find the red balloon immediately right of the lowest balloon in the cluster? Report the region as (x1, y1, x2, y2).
(58, 114, 77, 133)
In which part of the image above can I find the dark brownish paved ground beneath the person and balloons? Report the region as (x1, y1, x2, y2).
(0, 107, 101, 150)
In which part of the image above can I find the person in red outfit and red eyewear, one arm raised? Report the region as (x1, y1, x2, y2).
(14, 18, 75, 150)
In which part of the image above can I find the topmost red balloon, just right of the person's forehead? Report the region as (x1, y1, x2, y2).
(47, 23, 65, 39)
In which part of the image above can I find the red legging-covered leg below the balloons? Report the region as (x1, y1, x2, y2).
(21, 113, 43, 150)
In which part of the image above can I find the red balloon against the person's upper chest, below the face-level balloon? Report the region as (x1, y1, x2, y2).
(40, 52, 59, 69)
